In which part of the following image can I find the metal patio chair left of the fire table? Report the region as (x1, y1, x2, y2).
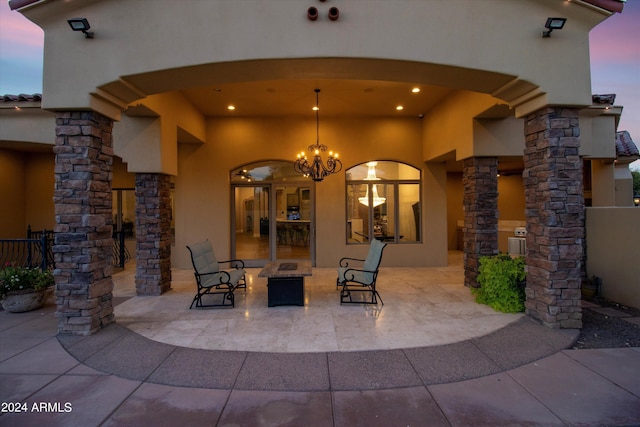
(187, 240, 247, 309)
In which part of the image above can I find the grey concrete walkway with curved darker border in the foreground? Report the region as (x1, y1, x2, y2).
(0, 304, 640, 427)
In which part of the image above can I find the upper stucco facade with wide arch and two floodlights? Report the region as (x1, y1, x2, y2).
(16, 0, 607, 115)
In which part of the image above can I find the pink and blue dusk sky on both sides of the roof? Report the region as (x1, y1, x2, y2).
(0, 0, 640, 169)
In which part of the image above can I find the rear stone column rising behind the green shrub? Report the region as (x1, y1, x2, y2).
(462, 157, 498, 288)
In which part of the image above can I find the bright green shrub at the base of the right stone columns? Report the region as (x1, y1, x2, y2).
(471, 254, 526, 313)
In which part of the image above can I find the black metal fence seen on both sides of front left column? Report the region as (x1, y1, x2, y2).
(0, 227, 131, 270)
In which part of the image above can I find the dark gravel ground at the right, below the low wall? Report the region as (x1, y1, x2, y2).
(573, 297, 640, 349)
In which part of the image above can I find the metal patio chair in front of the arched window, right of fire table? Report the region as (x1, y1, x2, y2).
(336, 239, 387, 305)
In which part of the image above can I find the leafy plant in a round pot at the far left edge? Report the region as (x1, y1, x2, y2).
(0, 264, 54, 313)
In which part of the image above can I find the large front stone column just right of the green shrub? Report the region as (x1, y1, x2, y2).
(523, 108, 585, 328)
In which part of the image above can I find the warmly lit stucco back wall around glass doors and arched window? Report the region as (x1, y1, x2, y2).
(172, 113, 447, 268)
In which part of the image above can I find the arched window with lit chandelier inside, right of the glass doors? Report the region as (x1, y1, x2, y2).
(346, 161, 422, 244)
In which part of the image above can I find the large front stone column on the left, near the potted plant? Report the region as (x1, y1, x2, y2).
(53, 111, 114, 335)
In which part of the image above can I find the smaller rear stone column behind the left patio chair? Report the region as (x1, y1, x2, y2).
(136, 173, 171, 295)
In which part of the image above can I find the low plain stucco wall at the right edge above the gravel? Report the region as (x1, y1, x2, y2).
(587, 207, 640, 308)
